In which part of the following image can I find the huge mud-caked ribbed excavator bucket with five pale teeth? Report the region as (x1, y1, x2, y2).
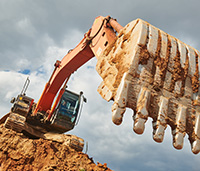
(96, 19, 200, 154)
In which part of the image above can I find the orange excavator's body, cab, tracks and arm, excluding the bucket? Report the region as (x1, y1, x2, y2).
(1, 17, 123, 150)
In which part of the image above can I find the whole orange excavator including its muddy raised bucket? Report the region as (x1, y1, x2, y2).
(0, 16, 200, 154)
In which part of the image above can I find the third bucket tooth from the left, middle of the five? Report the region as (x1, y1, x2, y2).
(153, 96, 169, 143)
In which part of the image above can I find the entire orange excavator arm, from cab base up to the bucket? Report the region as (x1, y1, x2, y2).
(33, 16, 123, 119)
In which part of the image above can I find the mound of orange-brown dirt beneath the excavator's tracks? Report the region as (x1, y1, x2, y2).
(0, 125, 110, 171)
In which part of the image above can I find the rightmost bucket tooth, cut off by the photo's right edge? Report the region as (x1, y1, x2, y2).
(192, 113, 200, 154)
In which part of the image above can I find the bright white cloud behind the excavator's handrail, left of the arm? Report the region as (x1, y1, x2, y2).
(0, 71, 45, 116)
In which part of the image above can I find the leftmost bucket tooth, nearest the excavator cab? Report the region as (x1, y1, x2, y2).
(112, 73, 129, 125)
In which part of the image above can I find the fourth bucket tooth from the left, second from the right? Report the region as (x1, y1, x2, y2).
(173, 105, 187, 149)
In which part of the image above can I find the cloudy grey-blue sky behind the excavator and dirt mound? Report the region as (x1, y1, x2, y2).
(0, 0, 200, 171)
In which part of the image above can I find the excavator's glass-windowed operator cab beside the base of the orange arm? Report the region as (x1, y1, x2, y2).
(50, 90, 86, 133)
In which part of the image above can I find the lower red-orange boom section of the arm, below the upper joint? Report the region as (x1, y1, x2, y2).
(34, 38, 94, 114)
